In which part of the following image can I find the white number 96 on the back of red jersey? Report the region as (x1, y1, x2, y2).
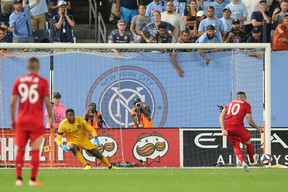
(18, 83, 39, 104)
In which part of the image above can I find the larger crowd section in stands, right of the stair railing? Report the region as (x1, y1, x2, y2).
(109, 0, 288, 51)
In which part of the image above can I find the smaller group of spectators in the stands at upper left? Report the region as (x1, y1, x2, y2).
(0, 0, 75, 43)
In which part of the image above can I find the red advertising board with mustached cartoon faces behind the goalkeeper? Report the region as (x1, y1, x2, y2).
(0, 128, 180, 167)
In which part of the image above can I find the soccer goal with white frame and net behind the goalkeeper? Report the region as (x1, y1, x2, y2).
(0, 43, 271, 167)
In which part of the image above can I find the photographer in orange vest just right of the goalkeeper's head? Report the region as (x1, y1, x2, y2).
(83, 103, 106, 129)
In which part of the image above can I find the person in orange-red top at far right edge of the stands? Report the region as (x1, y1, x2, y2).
(273, 13, 288, 51)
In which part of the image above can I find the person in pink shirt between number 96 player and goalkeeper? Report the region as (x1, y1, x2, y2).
(45, 92, 66, 129)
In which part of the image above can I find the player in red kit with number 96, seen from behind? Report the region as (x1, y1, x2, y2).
(10, 57, 53, 186)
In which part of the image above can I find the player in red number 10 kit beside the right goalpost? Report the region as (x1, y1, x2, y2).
(219, 91, 263, 171)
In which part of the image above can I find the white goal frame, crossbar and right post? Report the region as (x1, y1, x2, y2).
(0, 43, 271, 154)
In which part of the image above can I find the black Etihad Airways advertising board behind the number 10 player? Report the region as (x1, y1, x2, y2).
(181, 128, 288, 167)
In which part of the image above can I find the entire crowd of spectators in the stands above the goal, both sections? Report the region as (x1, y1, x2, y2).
(0, 0, 288, 51)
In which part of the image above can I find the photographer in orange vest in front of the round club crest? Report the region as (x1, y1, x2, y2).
(131, 99, 153, 128)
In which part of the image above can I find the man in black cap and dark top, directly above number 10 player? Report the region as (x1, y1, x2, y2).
(224, 19, 246, 43)
